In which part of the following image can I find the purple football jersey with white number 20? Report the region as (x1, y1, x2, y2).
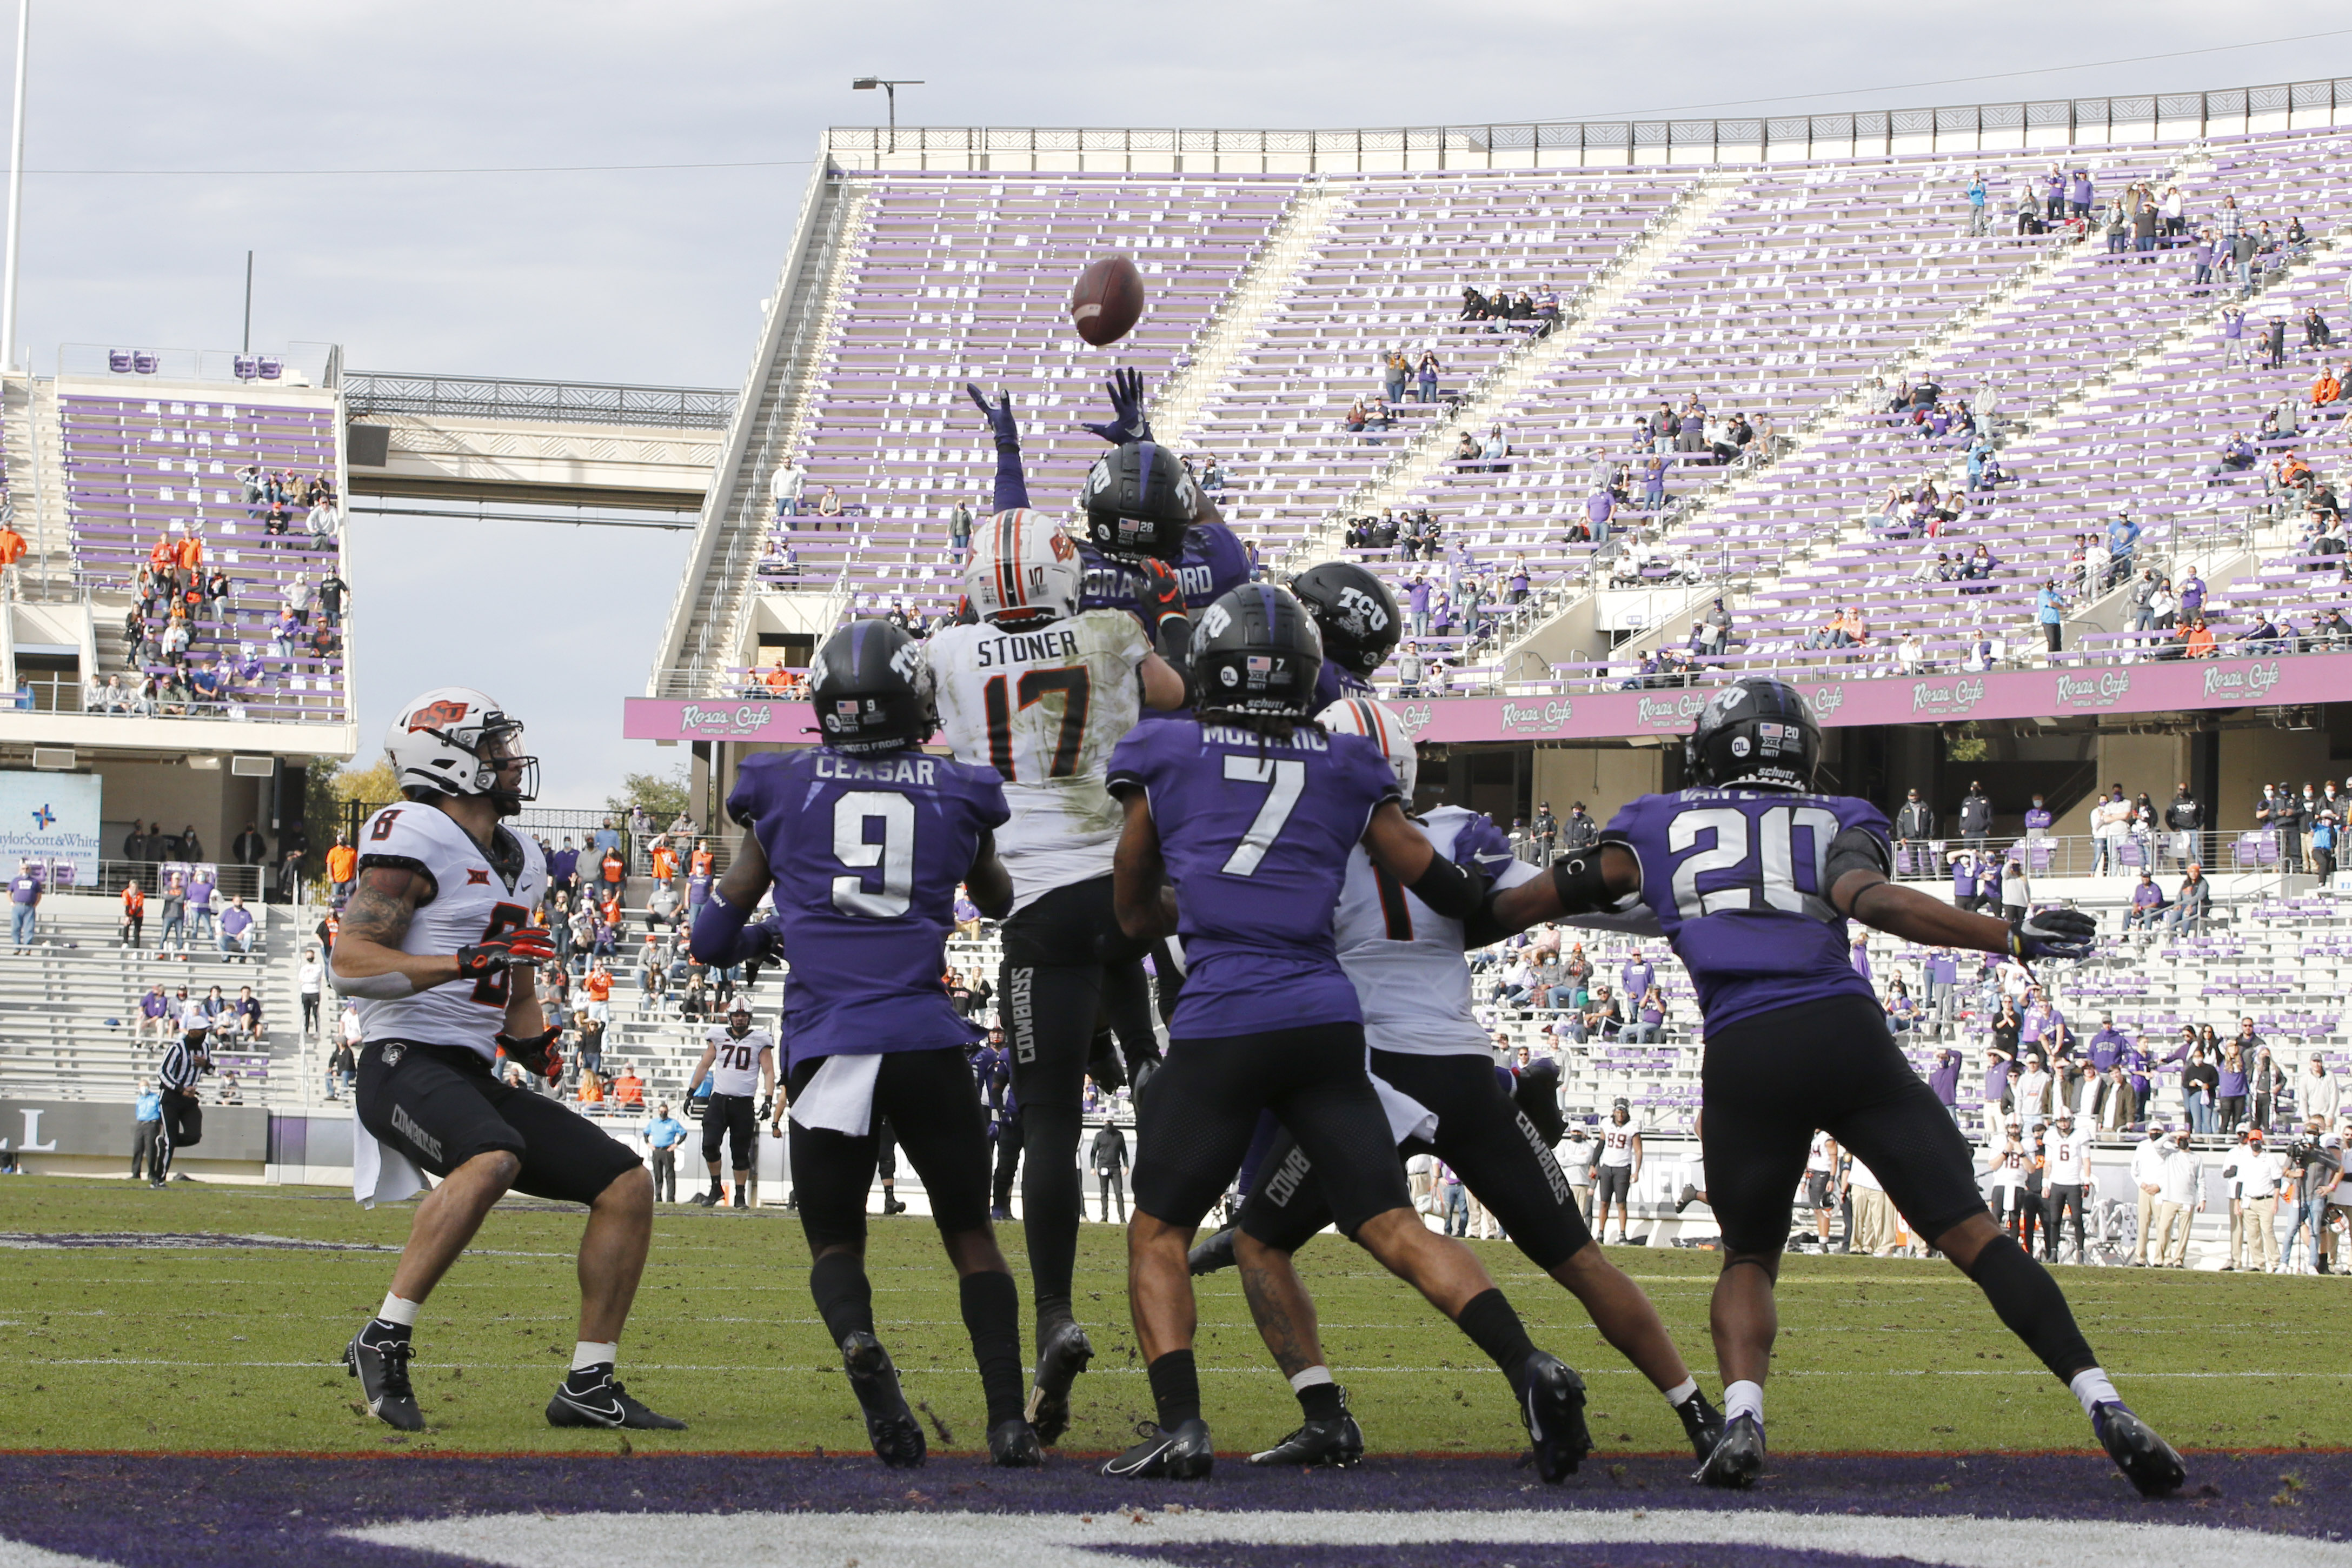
(1606, 790, 1893, 1029)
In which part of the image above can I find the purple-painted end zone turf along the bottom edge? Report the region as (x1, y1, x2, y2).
(0, 1451, 2352, 1568)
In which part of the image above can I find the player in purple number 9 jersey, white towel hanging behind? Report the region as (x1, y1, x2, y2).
(694, 621, 1044, 1465)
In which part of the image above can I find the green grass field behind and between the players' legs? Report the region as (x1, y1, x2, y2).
(0, 1178, 2352, 1453)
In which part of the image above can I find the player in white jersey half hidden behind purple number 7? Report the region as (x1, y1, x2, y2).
(1192, 698, 1722, 1467)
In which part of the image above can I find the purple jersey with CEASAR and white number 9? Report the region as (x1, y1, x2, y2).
(727, 748, 1009, 1062)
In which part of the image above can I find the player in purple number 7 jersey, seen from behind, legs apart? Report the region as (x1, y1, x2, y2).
(1106, 583, 1590, 1481)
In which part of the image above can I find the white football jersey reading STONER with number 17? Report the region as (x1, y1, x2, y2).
(922, 609, 1153, 910)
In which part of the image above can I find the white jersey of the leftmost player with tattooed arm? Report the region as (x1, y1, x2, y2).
(343, 802, 548, 1060)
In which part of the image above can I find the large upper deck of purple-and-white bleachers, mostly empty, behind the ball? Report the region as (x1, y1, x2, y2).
(656, 94, 2352, 696)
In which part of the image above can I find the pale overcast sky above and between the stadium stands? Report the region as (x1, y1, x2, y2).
(0, 0, 2352, 804)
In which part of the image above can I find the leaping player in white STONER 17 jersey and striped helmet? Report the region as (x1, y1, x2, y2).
(925, 510, 1190, 1444)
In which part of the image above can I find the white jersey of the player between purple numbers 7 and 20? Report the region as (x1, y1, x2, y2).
(1333, 806, 1536, 1055)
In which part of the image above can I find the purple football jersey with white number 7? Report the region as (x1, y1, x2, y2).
(1110, 722, 1397, 1039)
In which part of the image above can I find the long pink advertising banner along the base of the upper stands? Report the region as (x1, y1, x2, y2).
(621, 654, 2352, 745)
